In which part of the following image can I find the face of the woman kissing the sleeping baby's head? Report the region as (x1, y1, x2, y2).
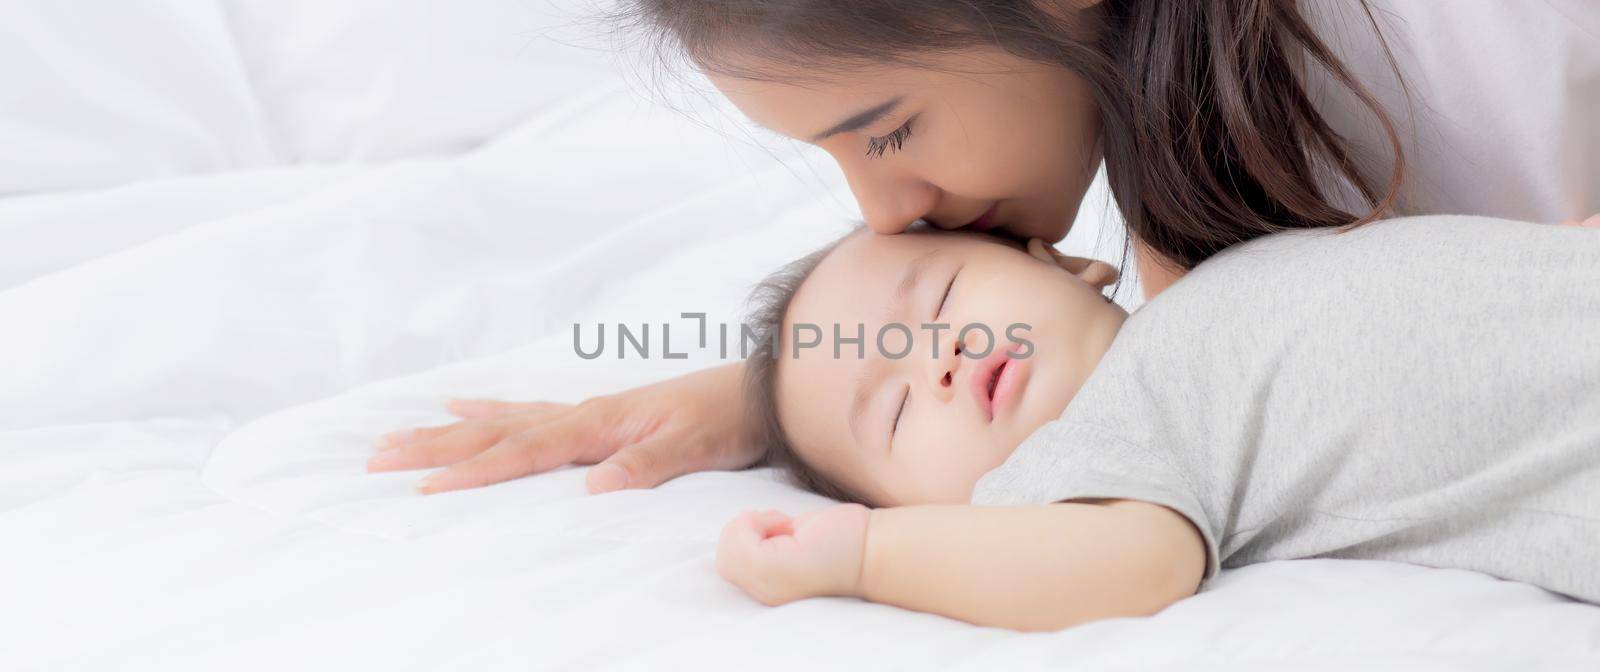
(712, 50, 1101, 240)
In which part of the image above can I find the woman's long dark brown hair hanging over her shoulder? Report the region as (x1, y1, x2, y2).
(611, 0, 1403, 269)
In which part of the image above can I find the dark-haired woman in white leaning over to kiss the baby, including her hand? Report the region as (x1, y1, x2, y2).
(368, 0, 1600, 493)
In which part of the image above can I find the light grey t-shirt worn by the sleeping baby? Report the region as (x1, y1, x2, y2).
(973, 216, 1600, 602)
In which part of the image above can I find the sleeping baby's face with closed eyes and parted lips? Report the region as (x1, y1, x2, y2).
(776, 232, 1126, 506)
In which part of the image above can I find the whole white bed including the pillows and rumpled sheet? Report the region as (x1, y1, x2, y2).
(0, 0, 1600, 670)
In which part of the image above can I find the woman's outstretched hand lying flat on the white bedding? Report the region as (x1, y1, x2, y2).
(366, 363, 760, 494)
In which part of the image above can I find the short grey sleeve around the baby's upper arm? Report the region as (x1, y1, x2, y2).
(973, 421, 1221, 579)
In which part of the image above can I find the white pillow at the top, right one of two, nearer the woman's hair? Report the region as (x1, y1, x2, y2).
(224, 0, 611, 162)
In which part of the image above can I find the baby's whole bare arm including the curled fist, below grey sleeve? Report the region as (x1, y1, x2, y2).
(717, 501, 1206, 630)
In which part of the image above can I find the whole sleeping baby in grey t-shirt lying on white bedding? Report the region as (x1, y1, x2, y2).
(717, 218, 1600, 630)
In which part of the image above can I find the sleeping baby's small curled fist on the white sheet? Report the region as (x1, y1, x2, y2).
(717, 504, 870, 606)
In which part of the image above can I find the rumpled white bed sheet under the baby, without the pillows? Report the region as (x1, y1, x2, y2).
(0, 74, 1600, 670)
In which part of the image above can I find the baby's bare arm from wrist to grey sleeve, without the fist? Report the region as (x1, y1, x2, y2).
(861, 499, 1205, 630)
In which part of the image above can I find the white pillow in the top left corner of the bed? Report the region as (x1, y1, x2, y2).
(0, 0, 275, 195)
